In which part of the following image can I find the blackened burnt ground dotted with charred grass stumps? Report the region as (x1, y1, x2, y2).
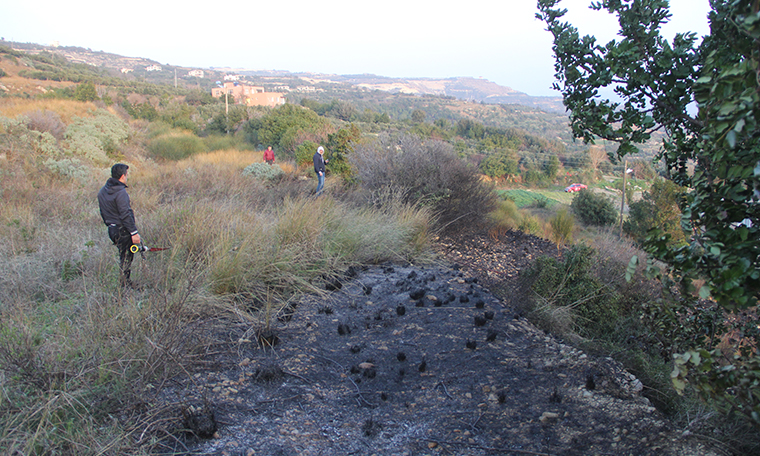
(157, 233, 721, 456)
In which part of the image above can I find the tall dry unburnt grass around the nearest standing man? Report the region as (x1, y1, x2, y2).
(0, 149, 433, 455)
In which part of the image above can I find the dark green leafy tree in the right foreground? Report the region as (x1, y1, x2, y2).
(536, 0, 760, 427)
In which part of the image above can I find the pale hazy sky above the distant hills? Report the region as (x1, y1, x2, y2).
(0, 0, 709, 96)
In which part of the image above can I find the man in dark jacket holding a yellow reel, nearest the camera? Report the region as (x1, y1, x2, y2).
(98, 163, 140, 287)
